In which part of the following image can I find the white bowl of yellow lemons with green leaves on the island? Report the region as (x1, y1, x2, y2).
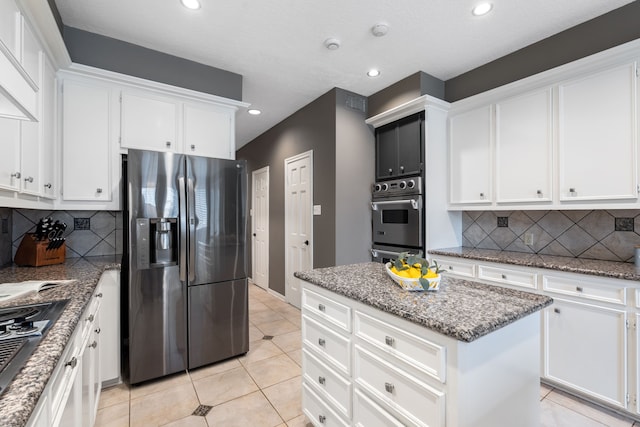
(385, 252, 442, 291)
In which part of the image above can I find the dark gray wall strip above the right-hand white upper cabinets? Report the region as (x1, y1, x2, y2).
(445, 1, 640, 102)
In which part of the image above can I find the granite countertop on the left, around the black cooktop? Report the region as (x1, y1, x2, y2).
(0, 256, 120, 427)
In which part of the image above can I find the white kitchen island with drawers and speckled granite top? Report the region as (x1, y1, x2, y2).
(295, 263, 553, 427)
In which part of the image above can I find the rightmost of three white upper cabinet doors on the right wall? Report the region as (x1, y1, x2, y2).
(558, 63, 637, 201)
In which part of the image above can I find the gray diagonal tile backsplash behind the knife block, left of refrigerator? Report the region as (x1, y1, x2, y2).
(11, 209, 123, 261)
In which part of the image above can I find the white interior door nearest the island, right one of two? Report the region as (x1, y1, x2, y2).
(284, 151, 313, 308)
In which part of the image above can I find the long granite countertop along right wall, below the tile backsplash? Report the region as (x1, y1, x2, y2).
(429, 247, 640, 280)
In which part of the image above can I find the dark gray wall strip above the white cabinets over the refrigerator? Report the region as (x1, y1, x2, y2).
(63, 26, 242, 101)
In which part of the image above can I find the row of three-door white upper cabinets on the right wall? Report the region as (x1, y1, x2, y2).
(449, 54, 640, 210)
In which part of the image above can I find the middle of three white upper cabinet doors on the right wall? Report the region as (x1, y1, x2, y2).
(496, 89, 553, 203)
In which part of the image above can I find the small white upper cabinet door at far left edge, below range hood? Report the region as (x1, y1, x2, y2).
(0, 118, 22, 191)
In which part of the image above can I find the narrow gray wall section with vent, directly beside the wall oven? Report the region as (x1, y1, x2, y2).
(335, 89, 375, 265)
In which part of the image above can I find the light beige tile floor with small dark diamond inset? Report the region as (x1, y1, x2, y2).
(96, 286, 640, 427)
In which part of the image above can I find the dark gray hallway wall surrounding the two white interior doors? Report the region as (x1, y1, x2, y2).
(236, 90, 336, 295)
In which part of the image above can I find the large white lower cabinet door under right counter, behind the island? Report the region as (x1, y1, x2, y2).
(544, 298, 627, 408)
